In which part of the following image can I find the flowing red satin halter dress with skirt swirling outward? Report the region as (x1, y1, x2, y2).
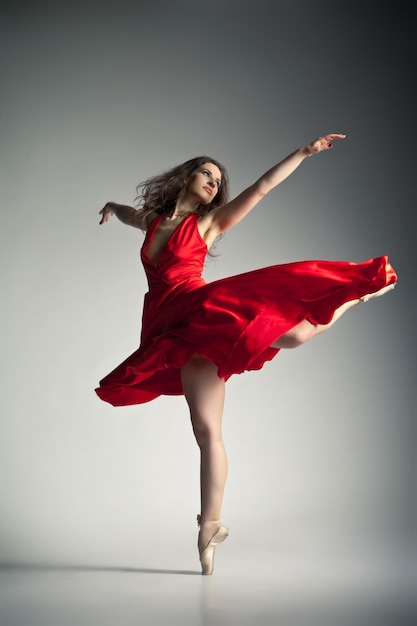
(96, 214, 396, 406)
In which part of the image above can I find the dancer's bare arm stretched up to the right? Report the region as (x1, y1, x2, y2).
(207, 133, 346, 234)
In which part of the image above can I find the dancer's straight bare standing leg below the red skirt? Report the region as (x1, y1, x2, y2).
(181, 355, 227, 552)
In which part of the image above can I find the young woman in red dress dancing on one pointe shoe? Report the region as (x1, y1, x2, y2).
(96, 134, 396, 574)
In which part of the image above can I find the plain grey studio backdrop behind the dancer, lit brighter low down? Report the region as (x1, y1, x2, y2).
(0, 0, 416, 567)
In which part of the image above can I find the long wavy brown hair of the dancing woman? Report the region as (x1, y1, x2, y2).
(135, 156, 229, 230)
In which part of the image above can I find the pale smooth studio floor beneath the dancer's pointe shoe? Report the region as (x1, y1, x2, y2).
(0, 547, 417, 626)
